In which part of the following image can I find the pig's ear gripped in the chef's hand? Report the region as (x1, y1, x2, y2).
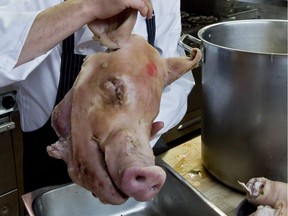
(88, 8, 137, 49)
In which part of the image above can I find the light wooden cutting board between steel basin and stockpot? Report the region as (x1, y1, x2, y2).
(160, 136, 245, 216)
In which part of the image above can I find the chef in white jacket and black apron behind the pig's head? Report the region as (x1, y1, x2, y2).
(0, 0, 194, 196)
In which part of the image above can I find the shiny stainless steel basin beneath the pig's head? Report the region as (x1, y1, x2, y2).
(22, 158, 226, 216)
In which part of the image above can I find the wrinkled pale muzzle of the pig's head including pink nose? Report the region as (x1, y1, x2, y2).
(97, 130, 166, 201)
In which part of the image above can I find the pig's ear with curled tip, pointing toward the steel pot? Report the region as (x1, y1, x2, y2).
(165, 48, 202, 86)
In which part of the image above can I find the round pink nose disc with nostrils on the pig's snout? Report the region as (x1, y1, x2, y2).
(120, 166, 166, 201)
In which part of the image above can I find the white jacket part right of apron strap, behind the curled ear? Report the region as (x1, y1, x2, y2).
(150, 0, 195, 146)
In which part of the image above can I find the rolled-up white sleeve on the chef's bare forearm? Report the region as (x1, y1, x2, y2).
(0, 1, 46, 87)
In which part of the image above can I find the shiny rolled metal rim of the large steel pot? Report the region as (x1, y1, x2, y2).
(197, 19, 288, 56)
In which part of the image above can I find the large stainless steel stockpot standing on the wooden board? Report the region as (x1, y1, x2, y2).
(181, 20, 287, 190)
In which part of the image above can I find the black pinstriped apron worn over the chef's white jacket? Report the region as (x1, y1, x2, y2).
(23, 14, 156, 193)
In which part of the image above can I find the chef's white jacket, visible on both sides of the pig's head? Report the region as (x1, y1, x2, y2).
(0, 0, 194, 146)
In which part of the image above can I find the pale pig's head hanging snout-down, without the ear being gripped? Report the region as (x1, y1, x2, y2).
(48, 35, 201, 204)
